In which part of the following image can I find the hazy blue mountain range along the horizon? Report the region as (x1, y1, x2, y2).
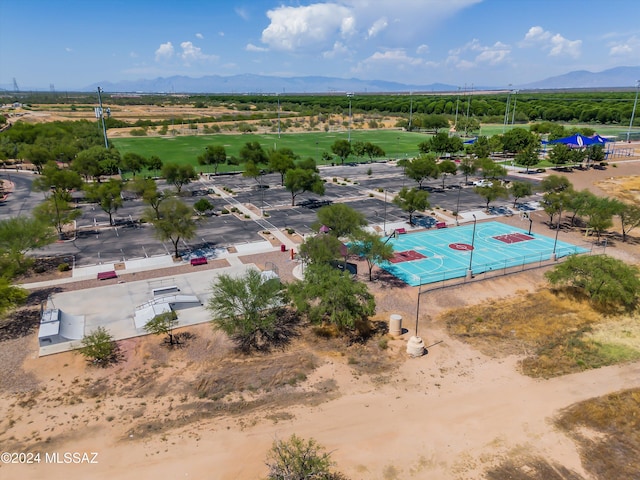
(0, 66, 640, 95)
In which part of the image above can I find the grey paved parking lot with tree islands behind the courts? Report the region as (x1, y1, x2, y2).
(0, 163, 540, 266)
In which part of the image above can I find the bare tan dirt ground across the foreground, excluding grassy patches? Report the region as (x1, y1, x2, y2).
(0, 125, 640, 480)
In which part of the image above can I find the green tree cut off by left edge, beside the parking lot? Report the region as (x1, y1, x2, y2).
(0, 216, 55, 272)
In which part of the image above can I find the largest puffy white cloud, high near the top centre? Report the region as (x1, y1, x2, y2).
(262, 3, 355, 51)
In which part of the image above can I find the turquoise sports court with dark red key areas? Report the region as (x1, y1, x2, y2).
(380, 222, 589, 287)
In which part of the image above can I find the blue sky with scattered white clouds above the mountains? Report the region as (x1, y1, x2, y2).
(0, 0, 640, 90)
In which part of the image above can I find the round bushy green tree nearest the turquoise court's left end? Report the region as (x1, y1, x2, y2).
(289, 264, 375, 332)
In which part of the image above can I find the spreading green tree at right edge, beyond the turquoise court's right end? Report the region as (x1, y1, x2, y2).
(545, 255, 640, 313)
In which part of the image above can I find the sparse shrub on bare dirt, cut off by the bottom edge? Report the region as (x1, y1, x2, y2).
(265, 434, 343, 480)
